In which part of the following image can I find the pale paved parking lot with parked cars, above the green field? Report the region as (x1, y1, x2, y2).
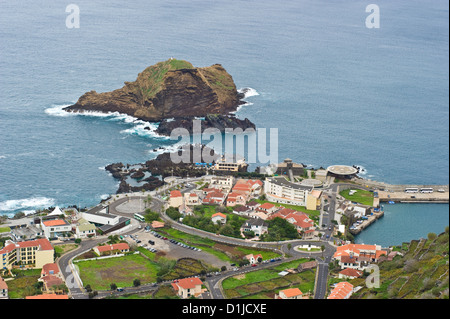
(124, 228, 230, 268)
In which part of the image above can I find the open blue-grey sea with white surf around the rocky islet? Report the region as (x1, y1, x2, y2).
(0, 0, 449, 245)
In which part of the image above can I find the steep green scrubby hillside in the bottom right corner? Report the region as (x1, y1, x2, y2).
(350, 227, 449, 299)
